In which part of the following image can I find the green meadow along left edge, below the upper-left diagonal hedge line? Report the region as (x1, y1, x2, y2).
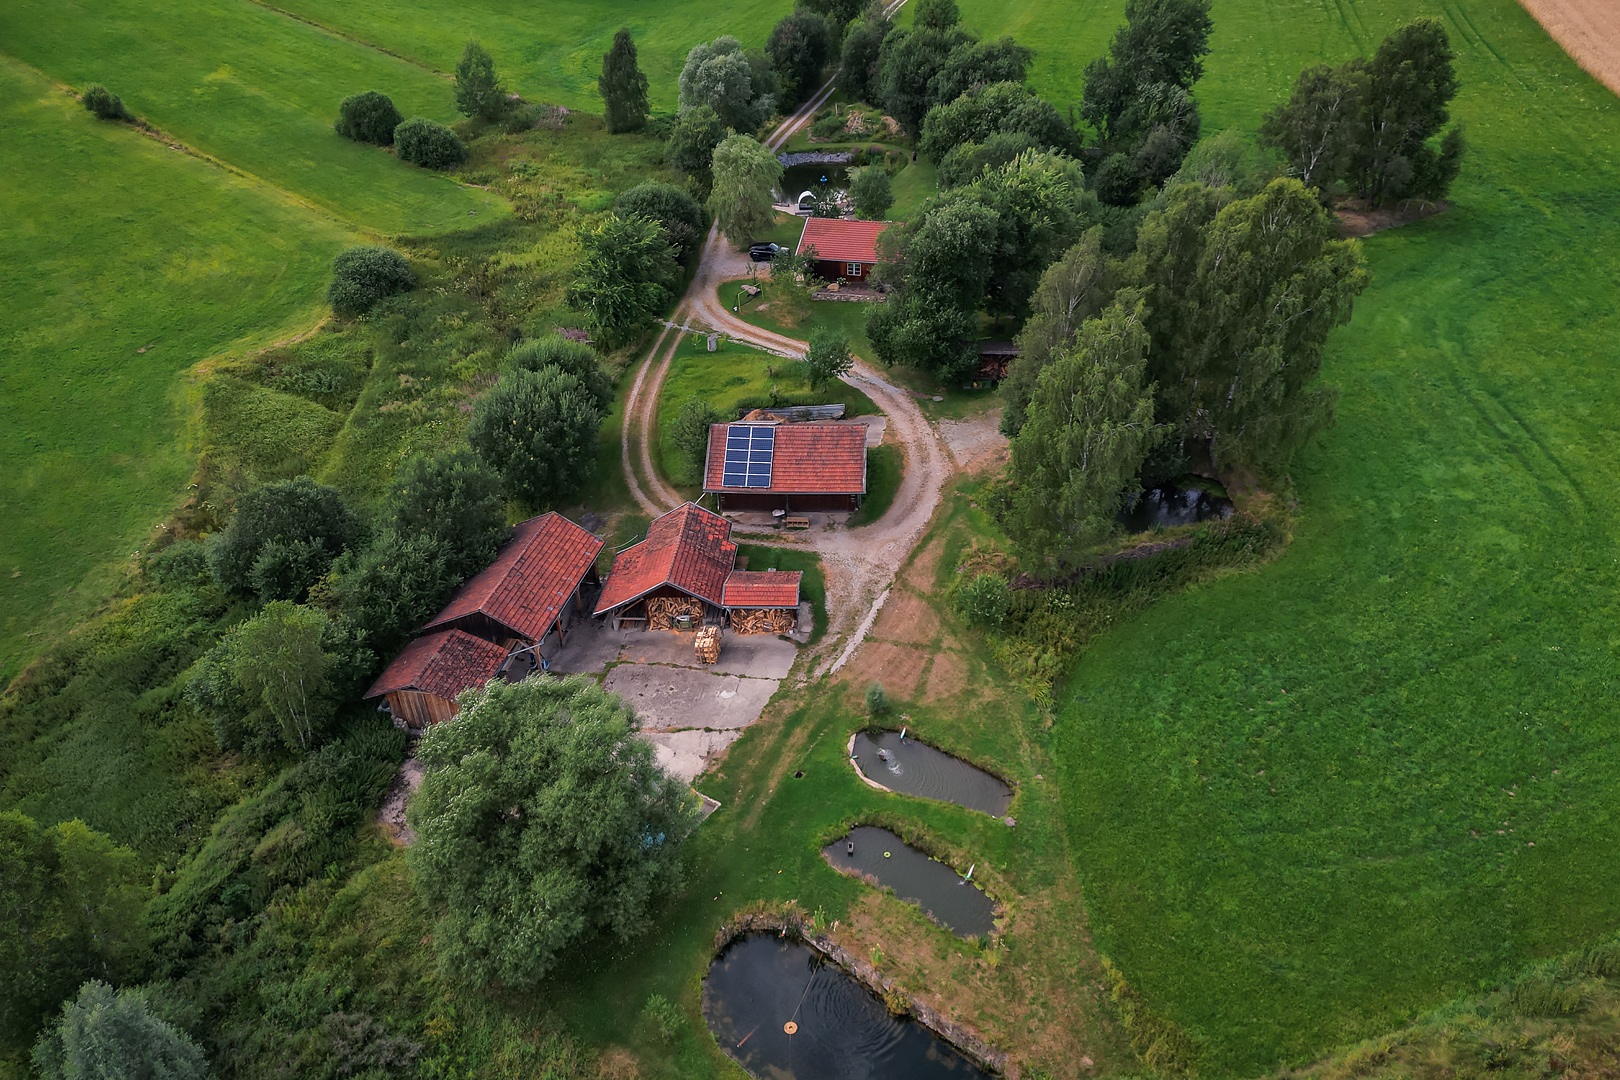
(0, 57, 352, 682)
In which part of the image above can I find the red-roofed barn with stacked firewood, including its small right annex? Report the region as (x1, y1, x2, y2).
(596, 502, 802, 631)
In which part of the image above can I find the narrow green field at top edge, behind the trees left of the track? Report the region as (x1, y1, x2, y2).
(230, 0, 792, 113)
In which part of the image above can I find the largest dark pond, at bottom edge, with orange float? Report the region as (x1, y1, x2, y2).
(703, 934, 990, 1080)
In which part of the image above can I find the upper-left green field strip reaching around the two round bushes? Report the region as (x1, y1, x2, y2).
(0, 0, 505, 233)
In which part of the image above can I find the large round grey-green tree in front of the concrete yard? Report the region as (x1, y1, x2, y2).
(407, 677, 695, 988)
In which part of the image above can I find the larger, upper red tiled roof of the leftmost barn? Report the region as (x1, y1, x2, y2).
(423, 513, 603, 641)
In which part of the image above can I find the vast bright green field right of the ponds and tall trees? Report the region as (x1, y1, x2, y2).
(939, 0, 1620, 1075)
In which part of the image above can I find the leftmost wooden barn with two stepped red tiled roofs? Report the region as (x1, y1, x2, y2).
(366, 513, 603, 727)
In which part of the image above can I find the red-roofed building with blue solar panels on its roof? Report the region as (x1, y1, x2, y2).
(703, 423, 867, 513)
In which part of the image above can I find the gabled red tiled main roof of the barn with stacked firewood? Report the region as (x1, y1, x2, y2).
(596, 502, 737, 615)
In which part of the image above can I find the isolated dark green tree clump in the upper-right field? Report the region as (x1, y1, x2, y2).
(1260, 18, 1464, 206)
